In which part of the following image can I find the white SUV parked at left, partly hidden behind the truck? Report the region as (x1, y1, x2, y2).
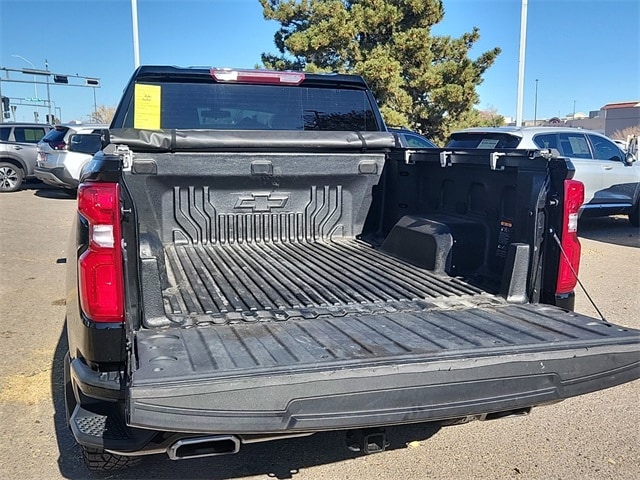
(34, 124, 109, 192)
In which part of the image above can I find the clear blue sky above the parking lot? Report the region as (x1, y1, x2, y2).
(0, 0, 640, 121)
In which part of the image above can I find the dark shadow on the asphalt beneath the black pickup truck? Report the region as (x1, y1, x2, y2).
(51, 329, 440, 479)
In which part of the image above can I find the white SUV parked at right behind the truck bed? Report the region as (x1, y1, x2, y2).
(445, 127, 640, 227)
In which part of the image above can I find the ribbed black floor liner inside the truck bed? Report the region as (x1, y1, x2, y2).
(156, 240, 502, 323)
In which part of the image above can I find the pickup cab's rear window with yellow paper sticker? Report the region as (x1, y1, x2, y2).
(122, 82, 380, 131)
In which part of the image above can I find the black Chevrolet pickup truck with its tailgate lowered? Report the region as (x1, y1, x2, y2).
(65, 66, 640, 469)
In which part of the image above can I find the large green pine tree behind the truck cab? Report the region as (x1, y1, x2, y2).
(260, 0, 500, 142)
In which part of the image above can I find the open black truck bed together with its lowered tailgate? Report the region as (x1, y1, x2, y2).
(116, 143, 640, 435)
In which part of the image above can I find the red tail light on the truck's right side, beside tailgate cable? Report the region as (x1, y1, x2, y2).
(556, 180, 584, 294)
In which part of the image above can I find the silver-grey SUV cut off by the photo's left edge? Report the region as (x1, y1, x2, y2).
(0, 123, 51, 192)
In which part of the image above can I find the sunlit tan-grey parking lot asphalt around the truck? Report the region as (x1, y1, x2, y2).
(0, 183, 640, 480)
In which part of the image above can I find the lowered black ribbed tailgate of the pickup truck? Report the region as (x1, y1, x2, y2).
(128, 301, 640, 434)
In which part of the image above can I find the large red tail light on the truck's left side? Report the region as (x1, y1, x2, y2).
(78, 183, 124, 322)
